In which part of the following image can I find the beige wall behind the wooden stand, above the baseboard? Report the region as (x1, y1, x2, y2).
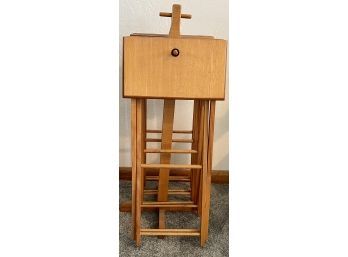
(119, 0, 228, 170)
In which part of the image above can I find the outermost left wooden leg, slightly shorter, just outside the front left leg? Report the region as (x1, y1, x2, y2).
(131, 99, 137, 240)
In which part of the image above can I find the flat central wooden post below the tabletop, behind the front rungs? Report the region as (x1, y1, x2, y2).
(157, 100, 175, 233)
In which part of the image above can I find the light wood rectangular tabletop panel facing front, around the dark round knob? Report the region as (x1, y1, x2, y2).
(123, 37, 226, 100)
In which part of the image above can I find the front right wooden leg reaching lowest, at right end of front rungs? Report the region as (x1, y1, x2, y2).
(199, 101, 209, 246)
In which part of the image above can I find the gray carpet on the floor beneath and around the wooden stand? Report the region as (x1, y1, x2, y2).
(119, 181, 228, 257)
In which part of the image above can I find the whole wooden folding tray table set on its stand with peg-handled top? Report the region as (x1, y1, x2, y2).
(123, 5, 227, 246)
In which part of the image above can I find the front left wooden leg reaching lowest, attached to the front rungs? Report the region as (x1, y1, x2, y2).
(135, 99, 143, 246)
